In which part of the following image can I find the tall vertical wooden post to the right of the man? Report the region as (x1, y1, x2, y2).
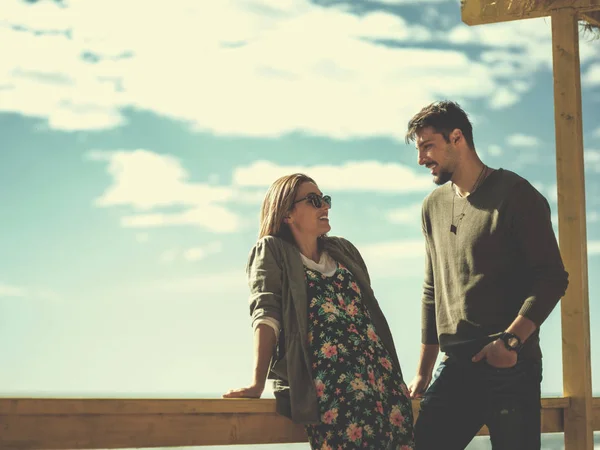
(552, 9, 594, 450)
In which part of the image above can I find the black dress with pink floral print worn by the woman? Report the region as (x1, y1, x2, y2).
(305, 263, 414, 450)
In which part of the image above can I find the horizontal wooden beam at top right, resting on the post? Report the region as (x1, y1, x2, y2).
(461, 0, 600, 25)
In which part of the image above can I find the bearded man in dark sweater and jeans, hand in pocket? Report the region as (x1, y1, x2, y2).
(406, 101, 568, 450)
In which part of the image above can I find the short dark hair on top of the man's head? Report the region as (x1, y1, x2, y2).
(405, 100, 475, 150)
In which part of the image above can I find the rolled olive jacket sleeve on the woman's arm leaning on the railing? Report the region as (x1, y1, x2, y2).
(246, 239, 282, 327)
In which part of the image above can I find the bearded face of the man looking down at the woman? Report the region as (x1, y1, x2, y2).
(416, 127, 456, 185)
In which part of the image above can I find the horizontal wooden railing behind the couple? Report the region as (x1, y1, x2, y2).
(0, 398, 600, 450)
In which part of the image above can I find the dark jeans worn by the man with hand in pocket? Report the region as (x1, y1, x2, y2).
(415, 357, 542, 450)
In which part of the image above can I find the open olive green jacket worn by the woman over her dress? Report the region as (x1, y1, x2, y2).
(246, 236, 400, 424)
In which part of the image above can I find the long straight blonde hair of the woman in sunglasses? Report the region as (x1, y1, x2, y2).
(258, 173, 316, 244)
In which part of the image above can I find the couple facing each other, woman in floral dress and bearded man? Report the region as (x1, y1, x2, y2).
(224, 102, 568, 450)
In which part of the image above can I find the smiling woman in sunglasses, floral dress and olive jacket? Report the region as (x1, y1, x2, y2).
(224, 174, 413, 450)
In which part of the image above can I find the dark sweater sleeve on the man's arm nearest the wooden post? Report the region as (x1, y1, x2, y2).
(508, 181, 569, 327)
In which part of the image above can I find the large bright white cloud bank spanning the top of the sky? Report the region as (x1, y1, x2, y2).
(0, 0, 598, 138)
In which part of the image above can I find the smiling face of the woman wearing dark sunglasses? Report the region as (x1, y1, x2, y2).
(287, 182, 331, 239)
